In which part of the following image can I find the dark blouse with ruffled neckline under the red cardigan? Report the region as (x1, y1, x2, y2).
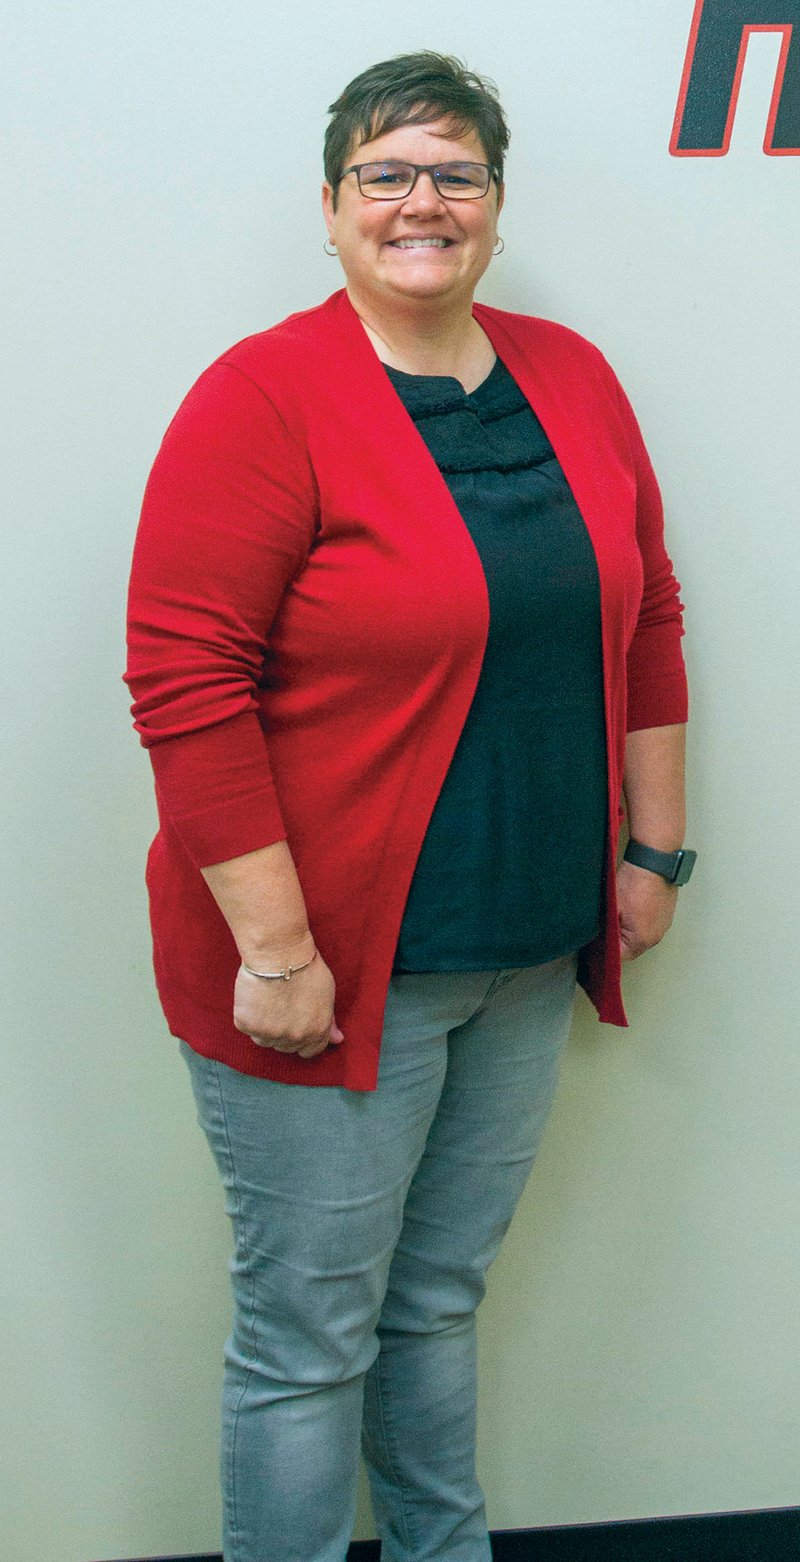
(386, 359, 606, 972)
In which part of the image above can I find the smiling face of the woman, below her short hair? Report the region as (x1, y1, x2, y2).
(322, 120, 503, 317)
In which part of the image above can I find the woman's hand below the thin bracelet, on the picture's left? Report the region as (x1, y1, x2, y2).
(233, 950, 344, 1059)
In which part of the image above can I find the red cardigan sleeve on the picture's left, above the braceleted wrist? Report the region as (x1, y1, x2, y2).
(123, 359, 317, 867)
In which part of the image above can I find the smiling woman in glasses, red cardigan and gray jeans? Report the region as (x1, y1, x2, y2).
(127, 53, 692, 1562)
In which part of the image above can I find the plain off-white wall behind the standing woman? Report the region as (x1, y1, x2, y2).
(0, 0, 800, 1562)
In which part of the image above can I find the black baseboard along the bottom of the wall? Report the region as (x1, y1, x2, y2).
(106, 1507, 800, 1562)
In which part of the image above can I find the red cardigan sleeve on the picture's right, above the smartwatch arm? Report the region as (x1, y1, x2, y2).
(614, 375, 689, 733)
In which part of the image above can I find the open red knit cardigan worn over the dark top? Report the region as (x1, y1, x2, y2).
(125, 291, 686, 1090)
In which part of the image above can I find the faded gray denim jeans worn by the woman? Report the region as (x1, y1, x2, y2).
(180, 954, 577, 1562)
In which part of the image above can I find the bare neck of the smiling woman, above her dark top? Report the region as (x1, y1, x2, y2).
(347, 289, 494, 384)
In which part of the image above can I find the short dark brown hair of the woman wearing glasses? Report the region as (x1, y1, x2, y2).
(325, 48, 509, 201)
